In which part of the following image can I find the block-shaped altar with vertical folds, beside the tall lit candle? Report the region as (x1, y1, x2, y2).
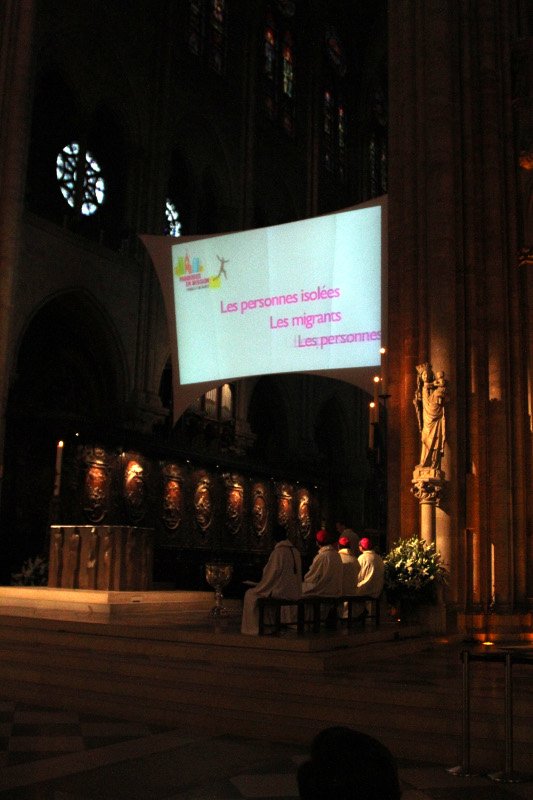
(48, 525, 154, 591)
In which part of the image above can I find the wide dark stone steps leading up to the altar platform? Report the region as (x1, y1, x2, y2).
(0, 619, 533, 770)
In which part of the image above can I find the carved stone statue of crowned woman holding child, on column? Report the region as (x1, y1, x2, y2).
(413, 363, 448, 470)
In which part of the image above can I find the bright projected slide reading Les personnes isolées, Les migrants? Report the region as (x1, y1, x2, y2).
(172, 205, 382, 384)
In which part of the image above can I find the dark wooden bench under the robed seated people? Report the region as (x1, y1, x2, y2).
(257, 594, 381, 636)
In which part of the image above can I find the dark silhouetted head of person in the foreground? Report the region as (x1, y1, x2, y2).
(297, 726, 402, 800)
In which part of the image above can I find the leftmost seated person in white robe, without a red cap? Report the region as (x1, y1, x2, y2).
(241, 526, 302, 636)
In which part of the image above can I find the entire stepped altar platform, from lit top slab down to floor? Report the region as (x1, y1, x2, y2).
(0, 587, 533, 771)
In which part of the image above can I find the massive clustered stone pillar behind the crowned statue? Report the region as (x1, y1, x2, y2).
(388, 0, 531, 611)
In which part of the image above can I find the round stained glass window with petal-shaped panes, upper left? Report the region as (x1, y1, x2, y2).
(56, 142, 105, 217)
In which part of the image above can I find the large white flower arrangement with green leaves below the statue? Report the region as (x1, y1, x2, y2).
(384, 536, 448, 604)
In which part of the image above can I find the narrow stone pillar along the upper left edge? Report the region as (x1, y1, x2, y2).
(0, 0, 34, 501)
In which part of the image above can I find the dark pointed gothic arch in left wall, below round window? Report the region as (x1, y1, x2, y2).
(0, 291, 125, 582)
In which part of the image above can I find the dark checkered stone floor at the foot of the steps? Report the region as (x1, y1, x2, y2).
(0, 701, 533, 800)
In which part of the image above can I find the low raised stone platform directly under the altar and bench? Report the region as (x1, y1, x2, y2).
(0, 586, 427, 672)
